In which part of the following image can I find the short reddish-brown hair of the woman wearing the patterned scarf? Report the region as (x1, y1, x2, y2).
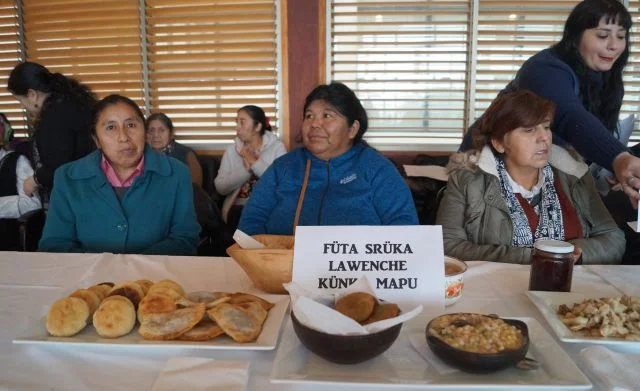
(472, 90, 556, 154)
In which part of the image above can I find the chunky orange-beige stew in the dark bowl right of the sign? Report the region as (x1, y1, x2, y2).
(428, 313, 525, 354)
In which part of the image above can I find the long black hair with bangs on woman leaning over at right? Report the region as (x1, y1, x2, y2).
(553, 0, 632, 133)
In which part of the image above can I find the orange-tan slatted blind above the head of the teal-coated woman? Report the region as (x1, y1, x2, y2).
(23, 0, 144, 106)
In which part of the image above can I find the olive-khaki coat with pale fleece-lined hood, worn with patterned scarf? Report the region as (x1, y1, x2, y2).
(436, 145, 625, 264)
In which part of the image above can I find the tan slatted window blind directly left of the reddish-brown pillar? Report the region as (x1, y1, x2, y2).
(146, 0, 278, 144)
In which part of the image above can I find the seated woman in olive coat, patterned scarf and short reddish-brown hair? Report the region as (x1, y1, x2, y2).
(436, 90, 625, 264)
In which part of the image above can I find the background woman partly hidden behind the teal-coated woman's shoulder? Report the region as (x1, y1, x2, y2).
(145, 113, 202, 187)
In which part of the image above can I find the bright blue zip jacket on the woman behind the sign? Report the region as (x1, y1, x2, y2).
(239, 144, 418, 235)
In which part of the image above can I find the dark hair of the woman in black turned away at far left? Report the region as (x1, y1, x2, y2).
(7, 62, 98, 114)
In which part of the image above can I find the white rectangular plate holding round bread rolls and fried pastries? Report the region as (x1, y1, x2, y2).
(13, 295, 289, 350)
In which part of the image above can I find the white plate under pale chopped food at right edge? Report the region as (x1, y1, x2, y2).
(527, 291, 640, 352)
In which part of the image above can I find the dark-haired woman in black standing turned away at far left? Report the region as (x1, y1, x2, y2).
(7, 62, 97, 202)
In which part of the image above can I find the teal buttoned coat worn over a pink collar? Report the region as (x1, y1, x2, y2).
(39, 146, 200, 255)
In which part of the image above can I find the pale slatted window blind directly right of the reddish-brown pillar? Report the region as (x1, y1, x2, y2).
(328, 0, 470, 149)
